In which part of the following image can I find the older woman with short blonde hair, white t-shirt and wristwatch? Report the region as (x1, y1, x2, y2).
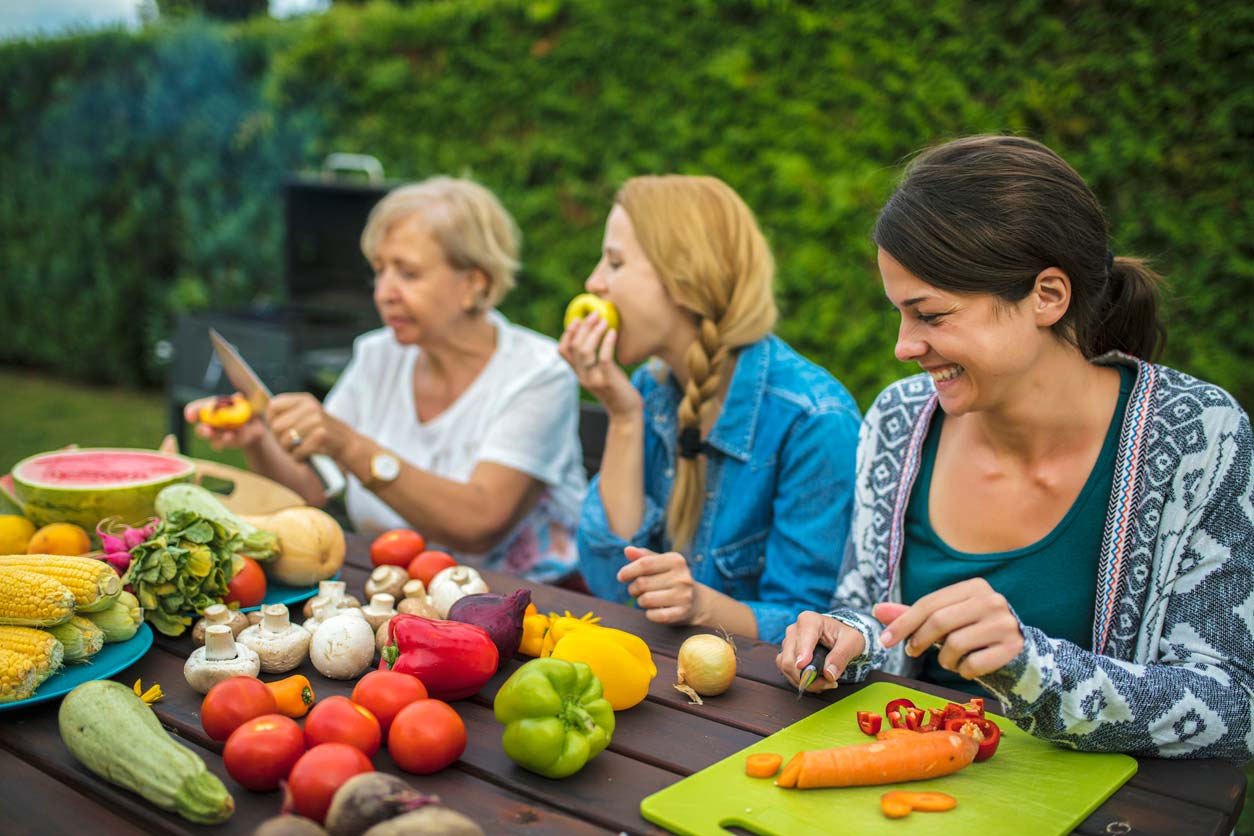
(186, 177, 584, 582)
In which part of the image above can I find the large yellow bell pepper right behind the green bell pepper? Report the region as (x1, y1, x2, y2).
(549, 624, 657, 711)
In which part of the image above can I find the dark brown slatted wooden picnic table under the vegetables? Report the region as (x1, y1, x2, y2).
(0, 536, 1245, 836)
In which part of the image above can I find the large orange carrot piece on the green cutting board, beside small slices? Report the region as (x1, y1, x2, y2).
(775, 732, 979, 790)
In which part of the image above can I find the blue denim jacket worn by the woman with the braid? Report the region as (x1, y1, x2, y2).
(578, 336, 860, 642)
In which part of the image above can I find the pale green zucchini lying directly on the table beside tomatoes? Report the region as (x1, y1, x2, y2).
(56, 679, 234, 825)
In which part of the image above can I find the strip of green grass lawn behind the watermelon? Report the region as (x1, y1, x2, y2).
(0, 368, 243, 474)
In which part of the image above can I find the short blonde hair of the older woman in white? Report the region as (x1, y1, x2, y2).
(361, 177, 522, 307)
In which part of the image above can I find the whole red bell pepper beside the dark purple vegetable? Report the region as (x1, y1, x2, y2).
(379, 613, 499, 701)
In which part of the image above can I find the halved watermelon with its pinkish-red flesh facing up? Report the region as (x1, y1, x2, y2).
(13, 447, 196, 531)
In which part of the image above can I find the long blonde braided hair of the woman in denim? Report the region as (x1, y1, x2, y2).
(614, 174, 776, 549)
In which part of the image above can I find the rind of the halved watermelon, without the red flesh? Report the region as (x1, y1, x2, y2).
(11, 447, 196, 531)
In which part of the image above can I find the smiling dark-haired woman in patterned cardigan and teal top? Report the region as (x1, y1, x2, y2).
(777, 137, 1254, 761)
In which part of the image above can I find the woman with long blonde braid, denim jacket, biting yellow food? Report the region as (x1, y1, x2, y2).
(558, 175, 860, 642)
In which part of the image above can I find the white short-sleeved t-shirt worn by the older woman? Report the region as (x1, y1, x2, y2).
(325, 311, 587, 580)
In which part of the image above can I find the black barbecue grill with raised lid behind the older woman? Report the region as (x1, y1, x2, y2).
(167, 154, 398, 447)
